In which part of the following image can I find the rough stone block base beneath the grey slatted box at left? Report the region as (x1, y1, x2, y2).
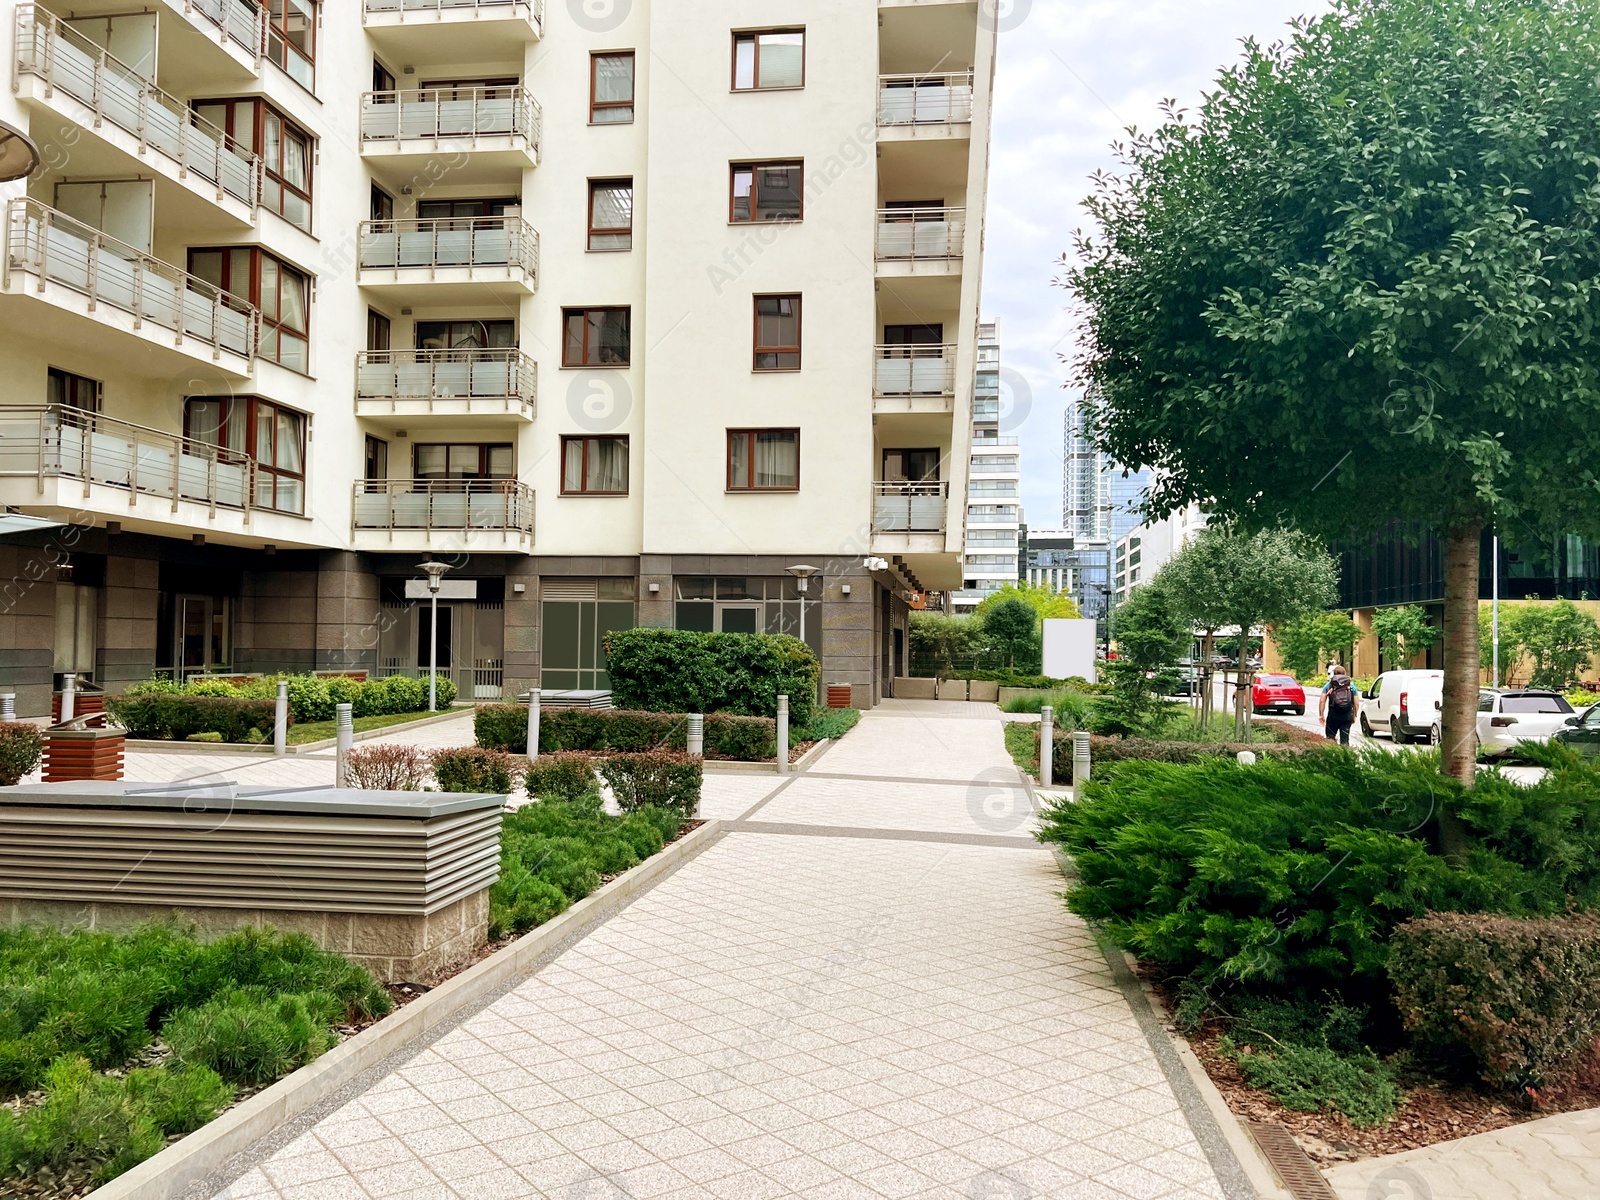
(0, 888, 490, 986)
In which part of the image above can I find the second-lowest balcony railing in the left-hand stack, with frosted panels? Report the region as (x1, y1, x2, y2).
(5, 197, 261, 358)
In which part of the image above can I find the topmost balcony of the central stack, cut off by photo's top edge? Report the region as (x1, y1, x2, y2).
(362, 0, 544, 62)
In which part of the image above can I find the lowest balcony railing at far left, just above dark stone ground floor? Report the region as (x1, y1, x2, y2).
(0, 405, 254, 512)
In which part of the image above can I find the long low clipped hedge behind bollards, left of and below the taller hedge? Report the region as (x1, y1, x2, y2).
(474, 704, 778, 762)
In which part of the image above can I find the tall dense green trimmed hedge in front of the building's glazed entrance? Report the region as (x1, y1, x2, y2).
(605, 629, 822, 725)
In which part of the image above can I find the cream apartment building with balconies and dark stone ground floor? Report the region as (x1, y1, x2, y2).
(0, 0, 994, 712)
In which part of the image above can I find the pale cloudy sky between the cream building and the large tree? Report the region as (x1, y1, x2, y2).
(982, 0, 1328, 530)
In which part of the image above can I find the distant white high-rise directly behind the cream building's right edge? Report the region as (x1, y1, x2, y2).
(950, 322, 1022, 613)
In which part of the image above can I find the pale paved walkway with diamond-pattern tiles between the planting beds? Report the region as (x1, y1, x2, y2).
(187, 702, 1248, 1200)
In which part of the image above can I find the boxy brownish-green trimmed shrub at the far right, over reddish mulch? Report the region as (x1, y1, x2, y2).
(1389, 914, 1600, 1090)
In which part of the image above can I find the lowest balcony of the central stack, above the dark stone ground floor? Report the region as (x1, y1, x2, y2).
(350, 478, 533, 552)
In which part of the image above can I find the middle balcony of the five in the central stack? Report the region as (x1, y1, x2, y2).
(358, 214, 539, 304)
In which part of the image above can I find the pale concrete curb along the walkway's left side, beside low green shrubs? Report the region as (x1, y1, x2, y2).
(86, 821, 722, 1200)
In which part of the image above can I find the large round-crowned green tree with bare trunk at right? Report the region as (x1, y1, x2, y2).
(1066, 0, 1600, 787)
